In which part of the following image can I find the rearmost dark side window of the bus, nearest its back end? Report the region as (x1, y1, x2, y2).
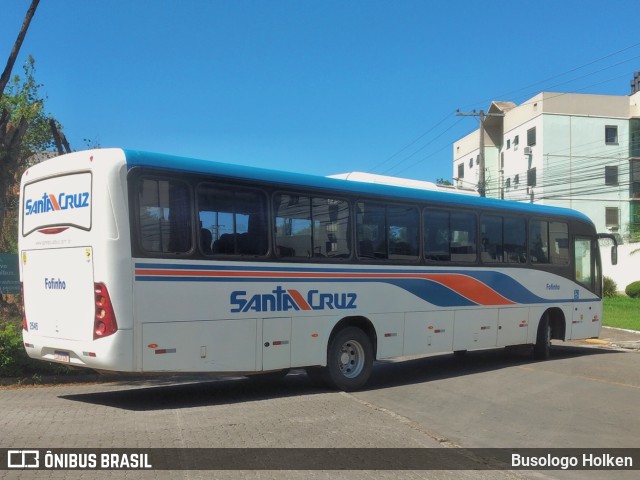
(138, 178, 193, 253)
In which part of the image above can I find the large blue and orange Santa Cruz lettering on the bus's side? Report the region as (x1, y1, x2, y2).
(229, 285, 358, 313)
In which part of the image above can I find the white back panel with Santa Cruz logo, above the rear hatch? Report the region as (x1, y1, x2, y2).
(22, 172, 92, 235)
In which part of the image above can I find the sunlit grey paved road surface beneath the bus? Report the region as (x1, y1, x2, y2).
(0, 324, 640, 479)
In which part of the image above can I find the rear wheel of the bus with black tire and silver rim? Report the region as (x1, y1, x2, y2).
(325, 327, 373, 392)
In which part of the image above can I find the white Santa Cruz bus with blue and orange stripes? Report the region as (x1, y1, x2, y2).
(19, 149, 616, 390)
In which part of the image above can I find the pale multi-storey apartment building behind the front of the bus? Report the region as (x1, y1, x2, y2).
(453, 91, 640, 240)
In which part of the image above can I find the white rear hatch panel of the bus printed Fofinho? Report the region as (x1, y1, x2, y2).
(20, 247, 95, 341)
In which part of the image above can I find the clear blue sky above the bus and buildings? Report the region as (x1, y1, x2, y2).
(0, 0, 640, 181)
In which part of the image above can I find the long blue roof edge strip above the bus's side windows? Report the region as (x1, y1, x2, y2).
(124, 150, 593, 223)
